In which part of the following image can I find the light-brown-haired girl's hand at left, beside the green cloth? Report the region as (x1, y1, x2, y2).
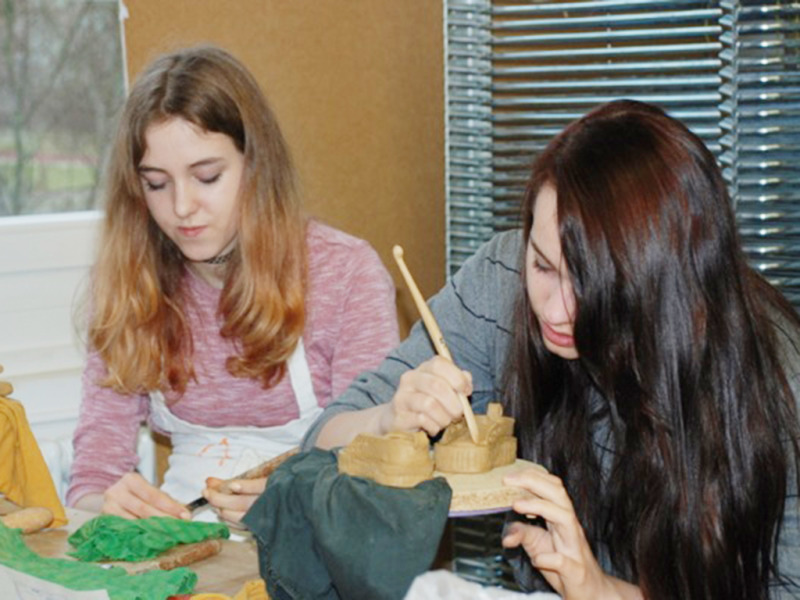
(101, 472, 192, 520)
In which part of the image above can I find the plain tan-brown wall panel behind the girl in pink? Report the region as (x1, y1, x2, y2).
(125, 0, 444, 334)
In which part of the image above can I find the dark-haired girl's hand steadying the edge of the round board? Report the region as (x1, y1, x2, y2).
(503, 468, 624, 600)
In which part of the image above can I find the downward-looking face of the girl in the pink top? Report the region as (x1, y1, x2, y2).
(137, 117, 244, 283)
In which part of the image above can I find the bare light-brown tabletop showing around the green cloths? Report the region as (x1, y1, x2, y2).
(24, 508, 259, 596)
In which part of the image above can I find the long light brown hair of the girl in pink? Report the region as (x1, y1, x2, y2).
(88, 46, 306, 394)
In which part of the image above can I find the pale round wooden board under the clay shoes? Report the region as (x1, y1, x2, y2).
(433, 458, 536, 517)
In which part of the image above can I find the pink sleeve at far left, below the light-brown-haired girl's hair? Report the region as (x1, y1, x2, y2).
(67, 353, 149, 506)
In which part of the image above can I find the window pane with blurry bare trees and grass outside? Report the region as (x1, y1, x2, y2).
(0, 0, 124, 217)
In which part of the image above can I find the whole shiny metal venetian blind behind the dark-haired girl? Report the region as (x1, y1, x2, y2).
(444, 0, 800, 587)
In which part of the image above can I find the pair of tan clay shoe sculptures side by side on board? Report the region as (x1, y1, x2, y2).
(339, 402, 517, 487)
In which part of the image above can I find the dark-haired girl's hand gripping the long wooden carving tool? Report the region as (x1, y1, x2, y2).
(381, 356, 472, 436)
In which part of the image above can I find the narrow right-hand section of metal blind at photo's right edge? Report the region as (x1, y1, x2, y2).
(719, 1, 800, 308)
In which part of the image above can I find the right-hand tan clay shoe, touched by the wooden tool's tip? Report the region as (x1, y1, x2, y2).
(433, 402, 517, 473)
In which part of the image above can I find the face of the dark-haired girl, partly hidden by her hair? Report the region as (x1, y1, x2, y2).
(525, 185, 578, 360)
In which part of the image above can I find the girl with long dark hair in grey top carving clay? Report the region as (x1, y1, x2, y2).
(307, 101, 800, 600)
